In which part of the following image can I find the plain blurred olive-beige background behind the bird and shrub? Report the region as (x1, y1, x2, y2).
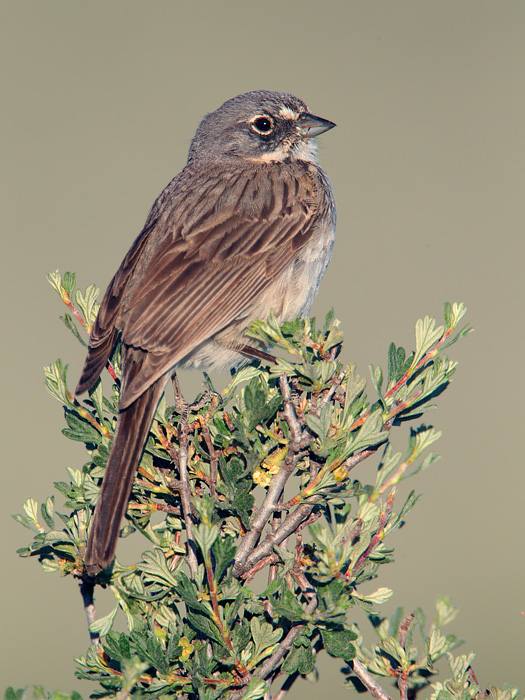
(0, 0, 525, 699)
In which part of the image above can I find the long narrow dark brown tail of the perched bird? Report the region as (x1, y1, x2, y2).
(84, 375, 167, 576)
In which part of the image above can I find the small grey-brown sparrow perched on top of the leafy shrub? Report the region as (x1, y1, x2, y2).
(76, 90, 336, 577)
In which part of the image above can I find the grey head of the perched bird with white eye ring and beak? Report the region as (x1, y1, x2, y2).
(188, 90, 335, 162)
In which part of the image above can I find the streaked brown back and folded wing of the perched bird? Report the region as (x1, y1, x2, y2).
(77, 163, 323, 408)
